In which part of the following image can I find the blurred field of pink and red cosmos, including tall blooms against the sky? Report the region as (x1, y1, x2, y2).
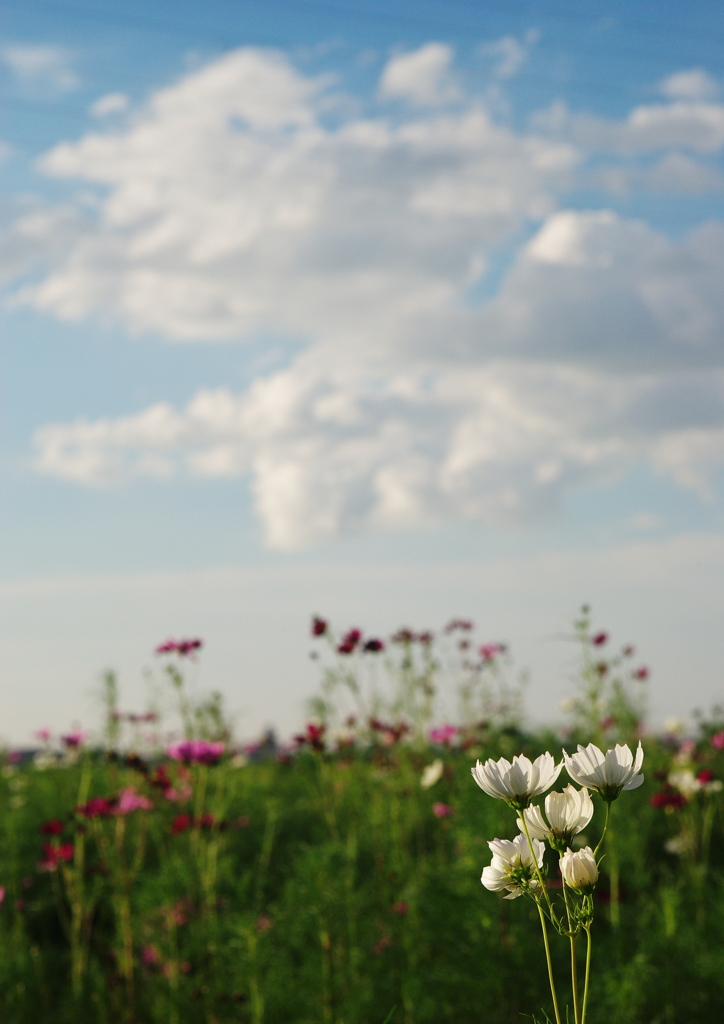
(0, 618, 724, 1024)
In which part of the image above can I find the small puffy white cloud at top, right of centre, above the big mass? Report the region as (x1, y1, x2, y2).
(380, 43, 462, 106)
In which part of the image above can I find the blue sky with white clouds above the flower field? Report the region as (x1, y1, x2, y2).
(0, 0, 724, 743)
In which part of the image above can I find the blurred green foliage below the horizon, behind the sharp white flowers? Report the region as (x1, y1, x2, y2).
(0, 734, 724, 1024)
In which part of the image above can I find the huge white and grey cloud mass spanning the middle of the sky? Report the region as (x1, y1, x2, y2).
(0, 43, 724, 547)
